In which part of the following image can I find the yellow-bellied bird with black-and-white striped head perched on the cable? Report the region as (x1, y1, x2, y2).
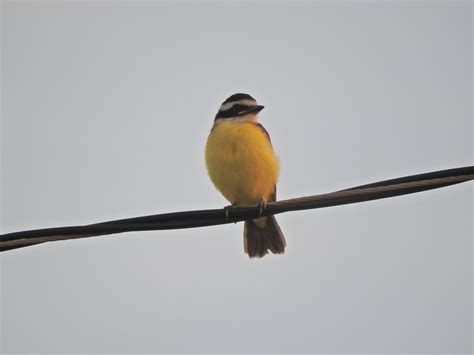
(205, 93, 286, 258)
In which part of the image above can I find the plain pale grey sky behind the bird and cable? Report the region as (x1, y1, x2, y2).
(0, 1, 473, 353)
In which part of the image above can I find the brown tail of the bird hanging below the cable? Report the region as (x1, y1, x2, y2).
(244, 216, 286, 258)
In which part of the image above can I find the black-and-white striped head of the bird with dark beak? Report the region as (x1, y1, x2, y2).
(215, 94, 264, 121)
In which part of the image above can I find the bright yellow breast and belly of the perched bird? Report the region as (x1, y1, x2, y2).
(206, 122, 279, 206)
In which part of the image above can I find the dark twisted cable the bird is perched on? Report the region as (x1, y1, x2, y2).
(0, 166, 474, 251)
